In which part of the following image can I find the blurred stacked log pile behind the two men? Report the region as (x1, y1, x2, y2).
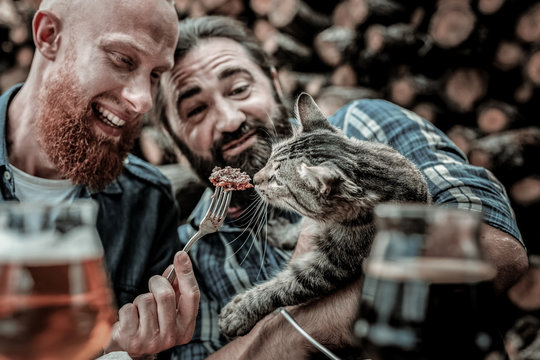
(0, 0, 540, 254)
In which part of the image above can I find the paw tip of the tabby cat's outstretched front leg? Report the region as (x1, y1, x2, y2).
(218, 293, 260, 338)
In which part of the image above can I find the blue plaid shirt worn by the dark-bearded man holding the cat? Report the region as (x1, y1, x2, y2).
(172, 100, 523, 360)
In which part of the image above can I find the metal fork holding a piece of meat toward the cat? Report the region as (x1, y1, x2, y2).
(167, 186, 232, 284)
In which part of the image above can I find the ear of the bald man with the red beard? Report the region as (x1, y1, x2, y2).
(32, 10, 61, 60)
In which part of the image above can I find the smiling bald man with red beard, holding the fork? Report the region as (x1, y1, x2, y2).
(0, 0, 199, 358)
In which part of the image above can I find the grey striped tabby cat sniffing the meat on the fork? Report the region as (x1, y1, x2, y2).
(219, 93, 430, 337)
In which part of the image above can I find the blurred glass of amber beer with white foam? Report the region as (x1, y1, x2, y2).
(0, 200, 116, 360)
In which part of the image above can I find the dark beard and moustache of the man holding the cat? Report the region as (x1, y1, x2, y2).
(174, 104, 292, 208)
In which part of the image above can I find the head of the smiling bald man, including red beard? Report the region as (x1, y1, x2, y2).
(23, 0, 178, 189)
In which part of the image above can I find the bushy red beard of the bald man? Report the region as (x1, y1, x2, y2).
(37, 69, 140, 191)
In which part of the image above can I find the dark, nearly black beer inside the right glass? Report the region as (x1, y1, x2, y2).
(354, 257, 506, 360)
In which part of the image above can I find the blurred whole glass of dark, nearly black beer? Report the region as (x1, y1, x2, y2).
(354, 204, 506, 360)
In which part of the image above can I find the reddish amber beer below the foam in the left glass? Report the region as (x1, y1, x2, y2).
(0, 259, 115, 360)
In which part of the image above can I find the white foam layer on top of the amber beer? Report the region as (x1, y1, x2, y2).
(0, 226, 103, 265)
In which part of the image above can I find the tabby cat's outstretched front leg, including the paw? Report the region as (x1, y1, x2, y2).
(219, 251, 353, 337)
